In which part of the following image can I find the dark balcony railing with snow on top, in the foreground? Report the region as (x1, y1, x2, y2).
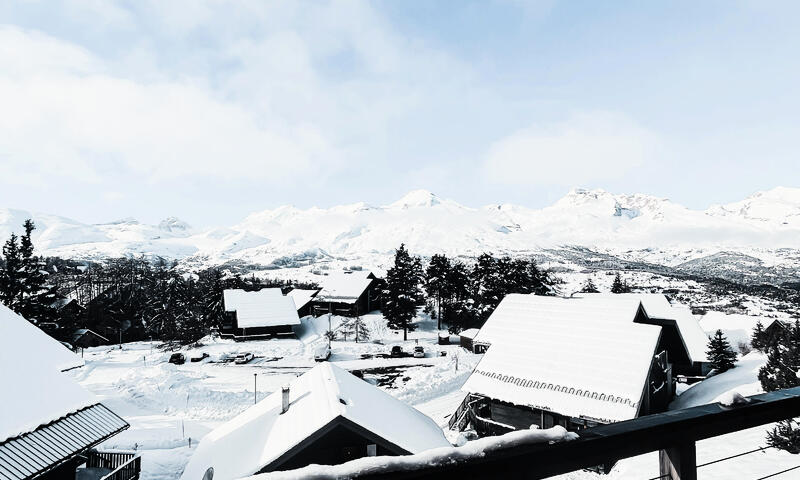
(257, 387, 800, 480)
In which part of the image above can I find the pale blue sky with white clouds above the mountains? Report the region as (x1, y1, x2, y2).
(0, 0, 800, 226)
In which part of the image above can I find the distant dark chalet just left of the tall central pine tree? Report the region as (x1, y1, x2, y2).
(312, 271, 383, 317)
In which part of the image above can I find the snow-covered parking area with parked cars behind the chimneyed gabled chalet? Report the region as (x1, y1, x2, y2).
(73, 314, 479, 480)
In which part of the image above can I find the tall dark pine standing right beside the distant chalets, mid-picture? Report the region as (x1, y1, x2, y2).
(383, 245, 422, 340)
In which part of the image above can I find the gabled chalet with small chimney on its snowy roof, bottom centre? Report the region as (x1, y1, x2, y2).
(181, 362, 450, 480)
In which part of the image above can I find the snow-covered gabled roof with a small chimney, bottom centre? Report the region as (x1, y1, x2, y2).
(181, 362, 450, 480)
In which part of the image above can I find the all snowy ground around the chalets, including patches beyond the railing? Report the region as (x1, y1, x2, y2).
(73, 304, 800, 480)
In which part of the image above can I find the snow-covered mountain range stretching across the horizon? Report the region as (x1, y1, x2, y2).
(0, 187, 800, 267)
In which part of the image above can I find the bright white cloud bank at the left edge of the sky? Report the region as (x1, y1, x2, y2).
(0, 24, 337, 186)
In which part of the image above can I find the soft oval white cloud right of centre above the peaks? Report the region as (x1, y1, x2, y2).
(484, 112, 659, 186)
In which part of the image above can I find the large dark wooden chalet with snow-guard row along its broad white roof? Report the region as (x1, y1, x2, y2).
(457, 294, 673, 434)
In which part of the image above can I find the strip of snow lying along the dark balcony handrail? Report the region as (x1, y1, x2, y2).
(244, 426, 578, 480)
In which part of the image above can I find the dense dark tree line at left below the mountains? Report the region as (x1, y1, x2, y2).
(0, 220, 315, 343)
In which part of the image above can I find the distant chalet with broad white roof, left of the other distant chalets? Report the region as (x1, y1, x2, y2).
(220, 288, 300, 340)
